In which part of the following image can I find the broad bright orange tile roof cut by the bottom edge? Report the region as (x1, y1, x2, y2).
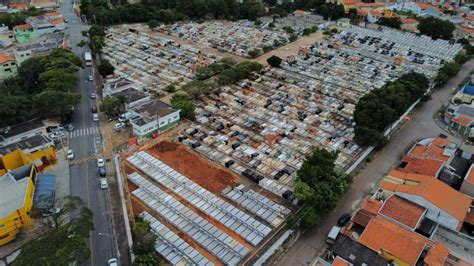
(359, 216, 431, 265)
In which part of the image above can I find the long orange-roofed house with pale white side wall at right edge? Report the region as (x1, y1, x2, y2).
(375, 170, 472, 231)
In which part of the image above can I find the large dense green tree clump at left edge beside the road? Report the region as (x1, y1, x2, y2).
(0, 49, 83, 127)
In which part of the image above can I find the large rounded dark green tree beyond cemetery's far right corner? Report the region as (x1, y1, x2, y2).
(418, 16, 456, 40)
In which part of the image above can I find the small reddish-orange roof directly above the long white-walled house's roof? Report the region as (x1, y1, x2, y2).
(397, 156, 444, 177)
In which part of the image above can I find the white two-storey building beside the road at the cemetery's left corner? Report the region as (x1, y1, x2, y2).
(131, 100, 180, 138)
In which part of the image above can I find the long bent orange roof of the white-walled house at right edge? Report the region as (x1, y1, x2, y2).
(380, 170, 472, 223)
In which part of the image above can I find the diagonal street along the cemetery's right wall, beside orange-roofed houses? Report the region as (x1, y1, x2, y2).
(278, 60, 474, 265)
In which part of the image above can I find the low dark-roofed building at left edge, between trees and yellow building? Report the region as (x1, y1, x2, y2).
(0, 119, 54, 155)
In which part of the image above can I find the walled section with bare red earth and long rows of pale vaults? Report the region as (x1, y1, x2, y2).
(122, 138, 291, 265)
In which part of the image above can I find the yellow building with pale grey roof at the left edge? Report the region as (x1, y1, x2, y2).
(0, 164, 38, 246)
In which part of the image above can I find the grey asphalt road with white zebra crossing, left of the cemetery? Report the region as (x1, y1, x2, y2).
(61, 0, 117, 265)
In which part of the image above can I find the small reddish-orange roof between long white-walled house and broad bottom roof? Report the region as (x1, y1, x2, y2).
(379, 195, 426, 229)
